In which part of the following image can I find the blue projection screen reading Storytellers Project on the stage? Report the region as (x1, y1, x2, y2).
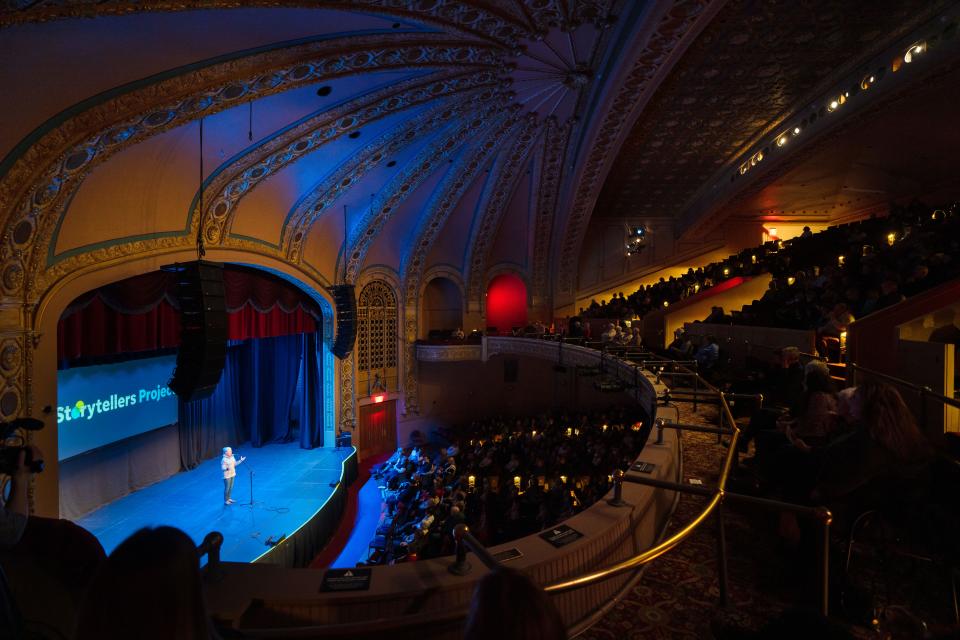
(57, 356, 177, 460)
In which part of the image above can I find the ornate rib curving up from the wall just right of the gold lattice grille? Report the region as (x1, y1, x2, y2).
(400, 105, 536, 415)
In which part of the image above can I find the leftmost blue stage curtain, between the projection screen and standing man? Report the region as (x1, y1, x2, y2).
(178, 340, 248, 469)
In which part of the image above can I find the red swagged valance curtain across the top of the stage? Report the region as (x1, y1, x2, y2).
(57, 267, 320, 363)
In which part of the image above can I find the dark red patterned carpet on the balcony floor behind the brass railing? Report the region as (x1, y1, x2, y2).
(579, 404, 955, 640)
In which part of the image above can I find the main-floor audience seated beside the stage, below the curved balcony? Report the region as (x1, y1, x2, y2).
(367, 408, 650, 564)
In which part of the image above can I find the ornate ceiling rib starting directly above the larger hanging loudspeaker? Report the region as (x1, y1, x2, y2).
(198, 71, 494, 244)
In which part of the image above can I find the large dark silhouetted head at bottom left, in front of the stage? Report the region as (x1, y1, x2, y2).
(75, 527, 216, 640)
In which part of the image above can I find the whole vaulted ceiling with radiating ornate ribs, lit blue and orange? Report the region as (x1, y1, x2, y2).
(0, 0, 950, 318)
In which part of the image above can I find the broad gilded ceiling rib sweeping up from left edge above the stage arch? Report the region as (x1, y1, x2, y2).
(0, 34, 497, 297)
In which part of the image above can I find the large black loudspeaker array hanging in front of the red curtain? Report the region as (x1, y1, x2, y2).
(163, 260, 227, 402)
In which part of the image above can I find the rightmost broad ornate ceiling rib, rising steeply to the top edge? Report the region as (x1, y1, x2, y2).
(553, 0, 723, 297)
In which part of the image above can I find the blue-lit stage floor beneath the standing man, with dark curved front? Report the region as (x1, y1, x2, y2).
(77, 443, 357, 567)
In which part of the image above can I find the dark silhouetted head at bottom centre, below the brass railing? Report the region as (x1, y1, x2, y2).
(463, 568, 567, 640)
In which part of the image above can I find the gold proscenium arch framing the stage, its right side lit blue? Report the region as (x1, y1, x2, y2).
(30, 249, 338, 518)
